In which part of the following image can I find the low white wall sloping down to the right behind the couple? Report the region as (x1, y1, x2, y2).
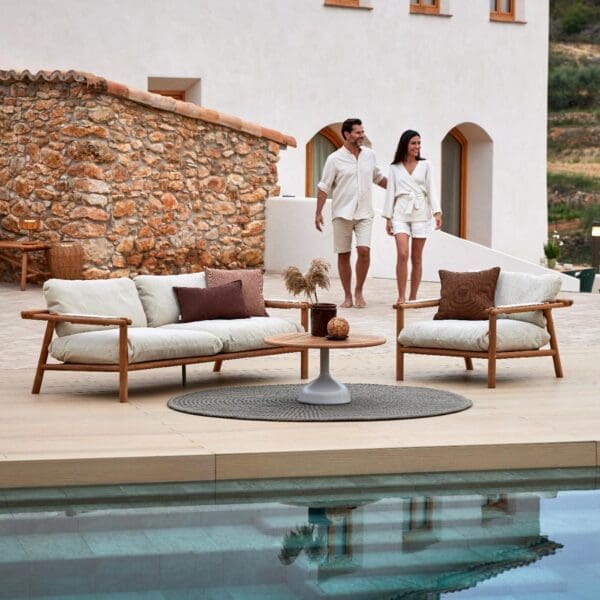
(265, 197, 579, 292)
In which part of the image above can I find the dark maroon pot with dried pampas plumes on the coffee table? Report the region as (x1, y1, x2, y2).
(283, 258, 337, 337)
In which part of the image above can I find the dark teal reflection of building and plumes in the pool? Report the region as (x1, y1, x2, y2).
(278, 493, 563, 600)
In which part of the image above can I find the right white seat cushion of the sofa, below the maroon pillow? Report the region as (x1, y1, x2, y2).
(161, 317, 304, 352)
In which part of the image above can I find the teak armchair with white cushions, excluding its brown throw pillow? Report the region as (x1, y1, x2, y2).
(394, 271, 573, 388)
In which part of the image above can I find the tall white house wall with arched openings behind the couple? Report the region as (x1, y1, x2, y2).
(0, 0, 548, 261)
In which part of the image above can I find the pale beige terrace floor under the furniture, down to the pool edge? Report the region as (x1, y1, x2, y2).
(0, 275, 600, 487)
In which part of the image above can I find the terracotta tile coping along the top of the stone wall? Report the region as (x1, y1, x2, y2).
(0, 70, 296, 148)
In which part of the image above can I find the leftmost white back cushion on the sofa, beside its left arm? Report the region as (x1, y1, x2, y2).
(44, 277, 147, 336)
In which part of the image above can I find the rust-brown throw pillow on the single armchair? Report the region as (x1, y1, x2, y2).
(433, 267, 500, 321)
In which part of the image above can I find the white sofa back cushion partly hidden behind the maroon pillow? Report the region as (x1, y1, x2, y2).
(133, 273, 206, 327)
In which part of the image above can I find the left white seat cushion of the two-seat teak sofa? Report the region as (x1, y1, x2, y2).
(50, 327, 223, 365)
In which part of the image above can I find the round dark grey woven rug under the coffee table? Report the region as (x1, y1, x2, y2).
(167, 383, 473, 421)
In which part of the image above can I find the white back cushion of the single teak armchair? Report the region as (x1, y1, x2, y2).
(494, 271, 560, 327)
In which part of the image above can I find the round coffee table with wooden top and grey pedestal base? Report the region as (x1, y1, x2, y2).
(265, 333, 385, 404)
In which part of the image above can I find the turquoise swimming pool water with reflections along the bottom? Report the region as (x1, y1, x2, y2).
(0, 469, 600, 600)
